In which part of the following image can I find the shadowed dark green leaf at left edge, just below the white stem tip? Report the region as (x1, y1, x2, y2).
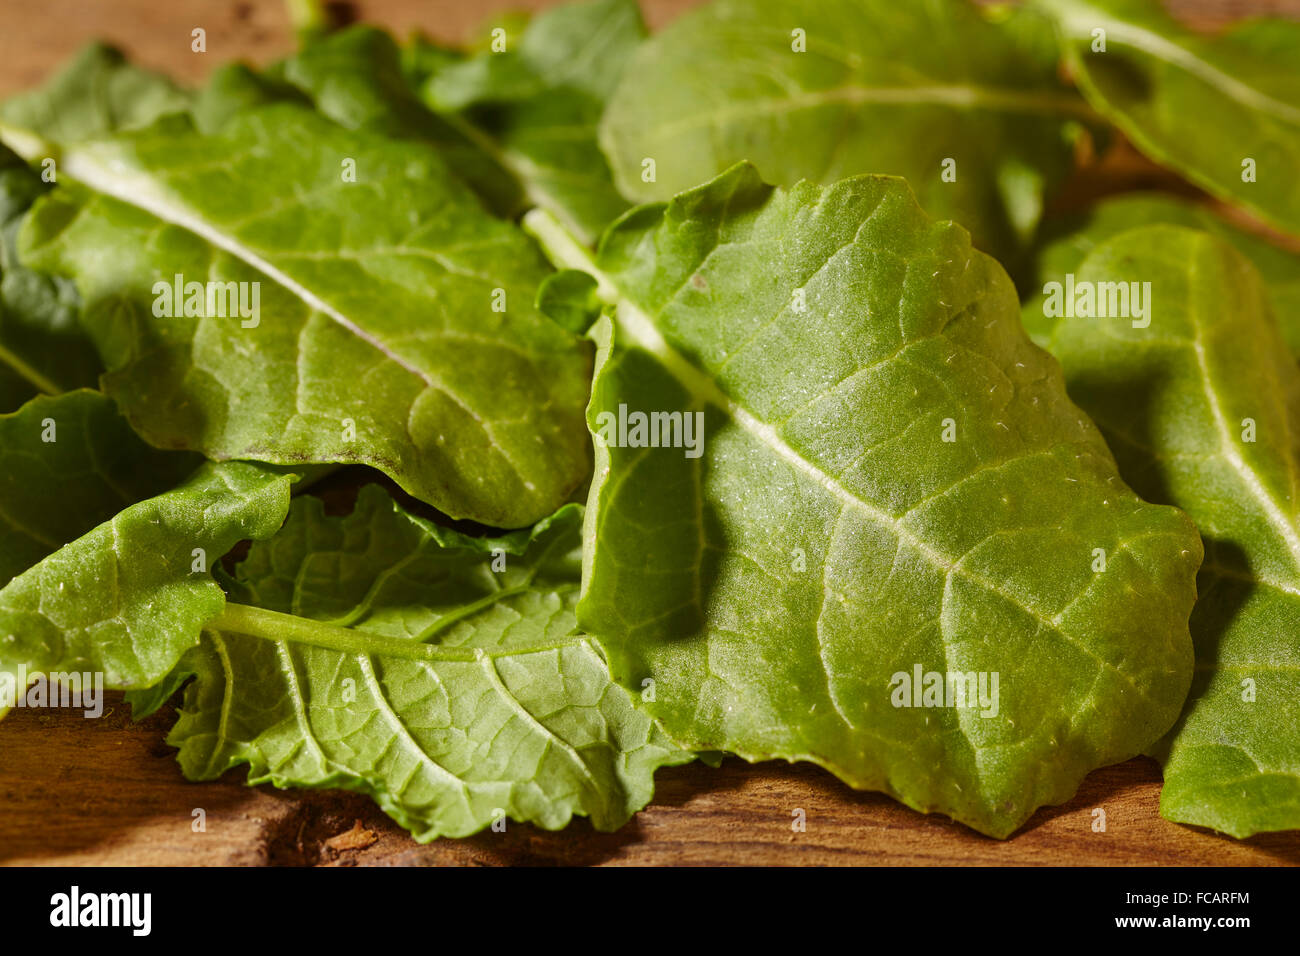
(0, 144, 100, 412)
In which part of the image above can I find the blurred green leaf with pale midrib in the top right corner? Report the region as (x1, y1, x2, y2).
(1036, 0, 1300, 243)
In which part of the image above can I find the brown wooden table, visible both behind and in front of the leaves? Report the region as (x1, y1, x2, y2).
(0, 0, 1300, 866)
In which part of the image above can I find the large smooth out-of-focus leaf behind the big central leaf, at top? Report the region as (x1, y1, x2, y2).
(601, 0, 1088, 260)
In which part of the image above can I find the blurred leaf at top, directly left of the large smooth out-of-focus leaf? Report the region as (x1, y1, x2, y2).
(423, 0, 646, 243)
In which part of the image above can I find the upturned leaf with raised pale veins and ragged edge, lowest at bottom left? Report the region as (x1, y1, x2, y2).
(157, 485, 693, 842)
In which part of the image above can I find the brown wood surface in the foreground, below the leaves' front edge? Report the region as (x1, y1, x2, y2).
(0, 695, 1300, 866)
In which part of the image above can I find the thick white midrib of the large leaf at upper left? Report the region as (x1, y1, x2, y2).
(0, 126, 436, 385)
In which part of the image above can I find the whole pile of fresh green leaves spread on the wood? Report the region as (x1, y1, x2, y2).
(0, 0, 1300, 840)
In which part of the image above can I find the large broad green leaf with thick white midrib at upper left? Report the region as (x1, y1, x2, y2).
(5, 104, 590, 527)
